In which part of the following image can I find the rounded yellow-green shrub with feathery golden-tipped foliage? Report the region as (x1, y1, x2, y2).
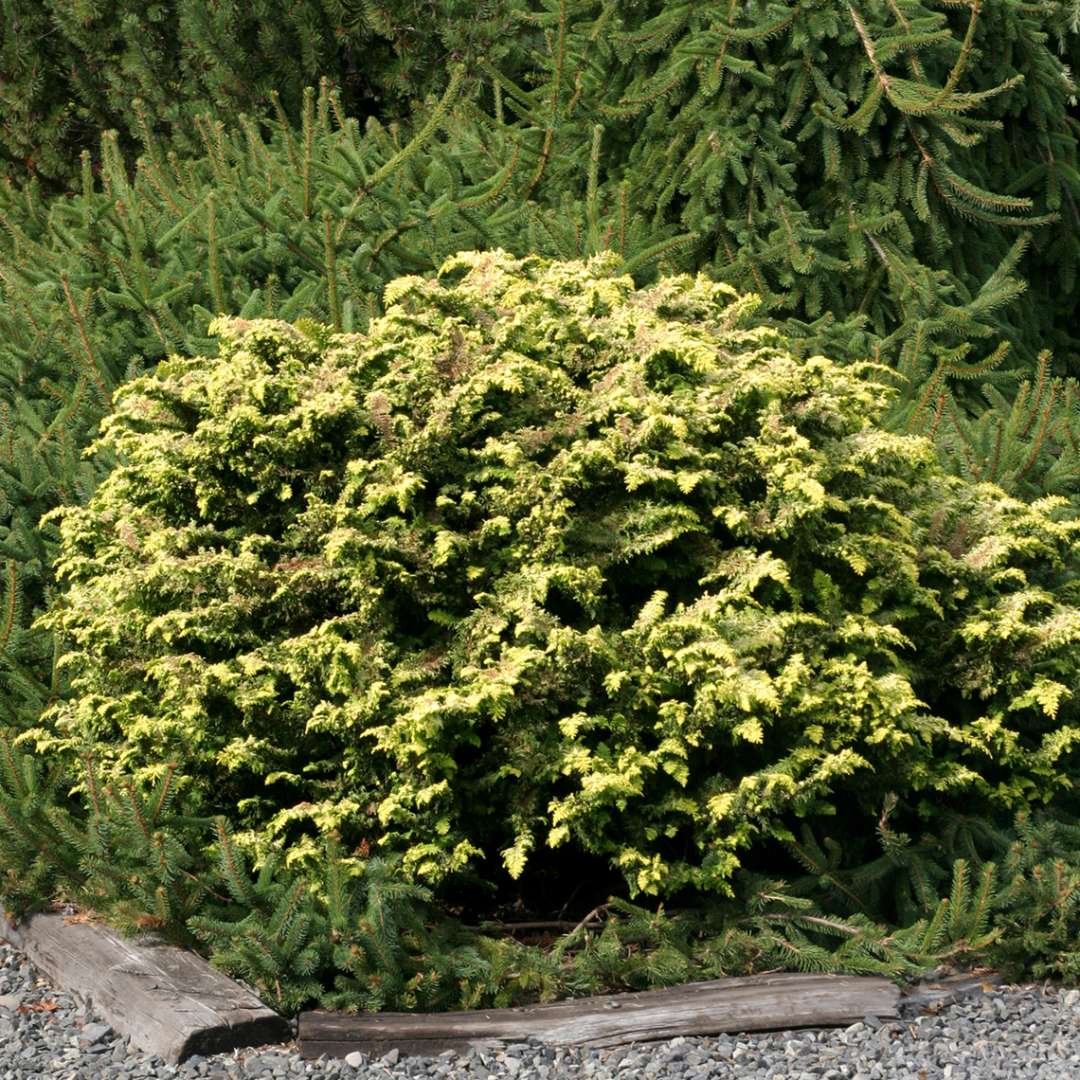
(27, 252, 1080, 896)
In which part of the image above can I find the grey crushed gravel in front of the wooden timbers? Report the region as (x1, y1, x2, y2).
(0, 944, 1080, 1080)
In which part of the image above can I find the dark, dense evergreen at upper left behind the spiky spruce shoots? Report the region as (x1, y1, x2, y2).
(0, 0, 521, 183)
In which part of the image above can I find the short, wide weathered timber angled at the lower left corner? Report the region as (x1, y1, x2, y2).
(0, 913, 293, 1065)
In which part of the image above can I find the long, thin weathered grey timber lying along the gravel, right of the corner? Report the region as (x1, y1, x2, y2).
(298, 973, 900, 1057)
